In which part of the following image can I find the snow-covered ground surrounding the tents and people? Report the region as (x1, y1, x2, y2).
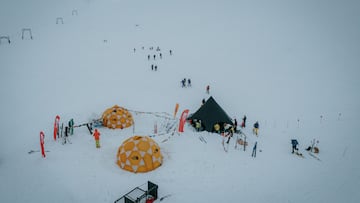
(0, 0, 360, 203)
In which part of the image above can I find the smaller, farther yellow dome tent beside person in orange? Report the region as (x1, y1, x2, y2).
(101, 105, 134, 129)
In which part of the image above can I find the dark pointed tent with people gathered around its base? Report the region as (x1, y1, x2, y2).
(188, 97, 233, 132)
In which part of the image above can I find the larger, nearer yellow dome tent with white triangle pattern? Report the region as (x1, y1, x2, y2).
(117, 135, 163, 173)
